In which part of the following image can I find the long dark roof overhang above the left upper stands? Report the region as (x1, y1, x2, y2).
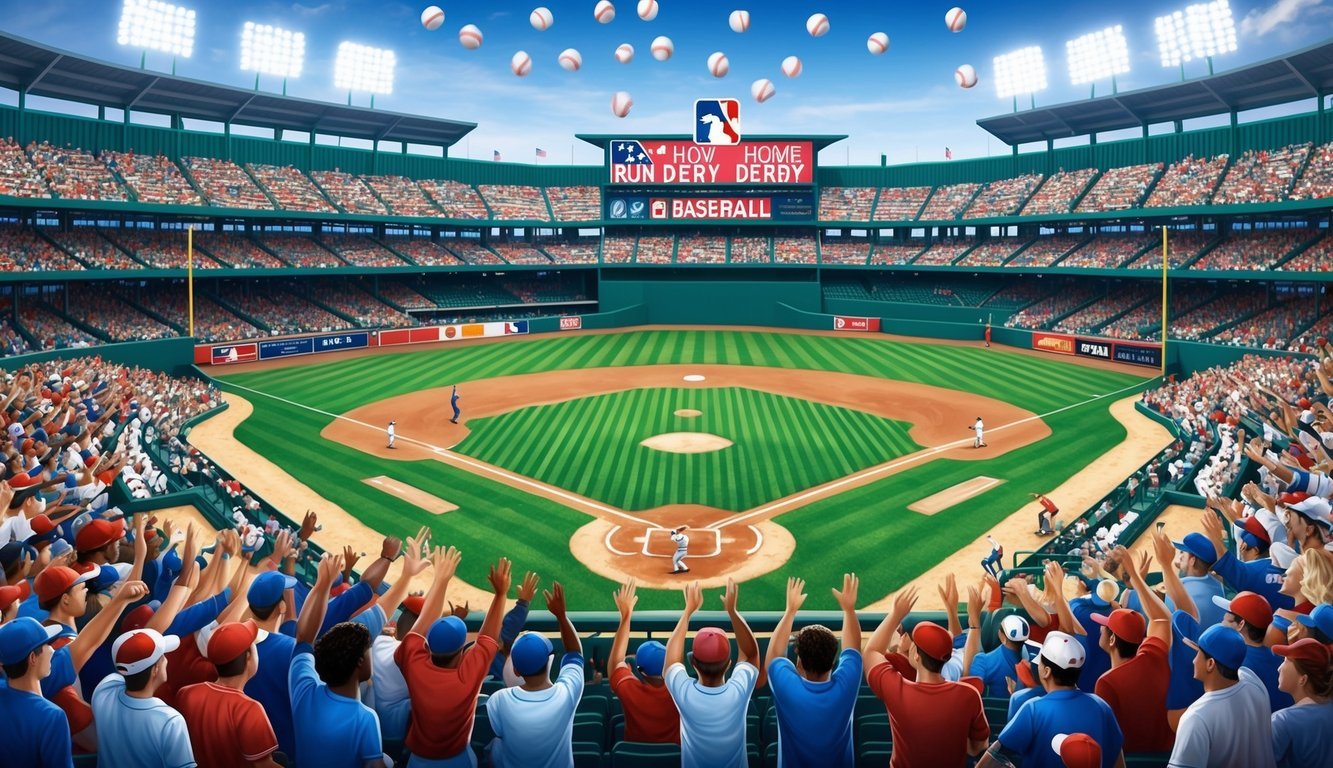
(0, 32, 477, 147)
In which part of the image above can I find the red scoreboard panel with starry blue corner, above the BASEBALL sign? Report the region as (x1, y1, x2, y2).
(611, 139, 814, 185)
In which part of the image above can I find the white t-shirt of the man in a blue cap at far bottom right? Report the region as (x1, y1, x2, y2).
(1167, 667, 1276, 768)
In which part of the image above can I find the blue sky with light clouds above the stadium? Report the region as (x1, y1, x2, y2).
(0, 0, 1333, 164)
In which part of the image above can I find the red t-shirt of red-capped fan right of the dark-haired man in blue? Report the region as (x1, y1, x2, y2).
(869, 664, 990, 768)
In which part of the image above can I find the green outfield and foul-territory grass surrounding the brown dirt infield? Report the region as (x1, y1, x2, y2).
(215, 331, 1144, 611)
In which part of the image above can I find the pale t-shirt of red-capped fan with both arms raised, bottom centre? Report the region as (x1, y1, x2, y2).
(667, 661, 758, 768)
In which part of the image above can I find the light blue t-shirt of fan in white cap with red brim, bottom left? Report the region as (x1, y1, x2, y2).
(92, 672, 195, 768)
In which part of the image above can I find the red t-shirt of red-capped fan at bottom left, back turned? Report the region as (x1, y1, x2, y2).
(177, 680, 277, 768)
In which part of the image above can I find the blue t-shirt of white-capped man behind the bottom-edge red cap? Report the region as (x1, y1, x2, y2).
(1000, 689, 1124, 768)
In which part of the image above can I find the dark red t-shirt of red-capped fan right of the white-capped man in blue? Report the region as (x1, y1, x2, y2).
(1094, 637, 1176, 752)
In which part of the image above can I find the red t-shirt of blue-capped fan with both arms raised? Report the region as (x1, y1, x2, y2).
(393, 632, 500, 760)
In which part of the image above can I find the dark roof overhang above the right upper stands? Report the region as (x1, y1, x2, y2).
(977, 40, 1333, 145)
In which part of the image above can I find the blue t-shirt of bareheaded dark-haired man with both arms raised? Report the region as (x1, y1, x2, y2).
(768, 648, 862, 768)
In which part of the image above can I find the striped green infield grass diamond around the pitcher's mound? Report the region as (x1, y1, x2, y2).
(455, 387, 920, 512)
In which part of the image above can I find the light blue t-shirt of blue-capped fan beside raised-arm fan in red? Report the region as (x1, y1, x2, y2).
(487, 653, 584, 768)
